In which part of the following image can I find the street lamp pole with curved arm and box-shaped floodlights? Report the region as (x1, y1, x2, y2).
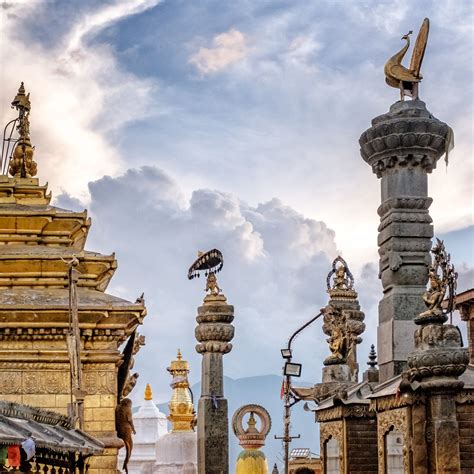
(275, 312, 323, 474)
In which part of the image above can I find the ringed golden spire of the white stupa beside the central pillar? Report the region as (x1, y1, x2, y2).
(167, 349, 196, 432)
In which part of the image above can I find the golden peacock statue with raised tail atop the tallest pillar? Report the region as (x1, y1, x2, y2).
(384, 18, 430, 100)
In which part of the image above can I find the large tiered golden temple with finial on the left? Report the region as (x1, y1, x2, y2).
(0, 84, 146, 474)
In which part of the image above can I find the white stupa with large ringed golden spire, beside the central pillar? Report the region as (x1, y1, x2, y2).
(153, 350, 197, 474)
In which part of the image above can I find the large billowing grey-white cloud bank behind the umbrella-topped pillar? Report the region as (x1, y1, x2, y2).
(57, 167, 344, 402)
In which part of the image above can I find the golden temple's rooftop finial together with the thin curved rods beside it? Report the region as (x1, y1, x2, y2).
(0, 82, 38, 178)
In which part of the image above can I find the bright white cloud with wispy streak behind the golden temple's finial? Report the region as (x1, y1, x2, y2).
(0, 0, 157, 199)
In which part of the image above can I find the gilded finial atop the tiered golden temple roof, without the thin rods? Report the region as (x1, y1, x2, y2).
(8, 82, 38, 178)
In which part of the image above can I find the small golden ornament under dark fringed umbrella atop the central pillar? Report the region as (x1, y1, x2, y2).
(188, 249, 227, 304)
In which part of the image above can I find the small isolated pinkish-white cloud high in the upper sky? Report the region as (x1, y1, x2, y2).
(189, 28, 249, 74)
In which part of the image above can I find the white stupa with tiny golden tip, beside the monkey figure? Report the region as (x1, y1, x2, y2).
(119, 384, 168, 474)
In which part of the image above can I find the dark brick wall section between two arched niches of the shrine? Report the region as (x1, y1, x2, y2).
(346, 418, 378, 474)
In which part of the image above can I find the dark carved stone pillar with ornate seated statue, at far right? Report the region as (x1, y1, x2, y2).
(404, 240, 469, 472)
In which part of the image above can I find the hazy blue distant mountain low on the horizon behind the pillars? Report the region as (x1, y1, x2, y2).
(158, 375, 319, 472)
